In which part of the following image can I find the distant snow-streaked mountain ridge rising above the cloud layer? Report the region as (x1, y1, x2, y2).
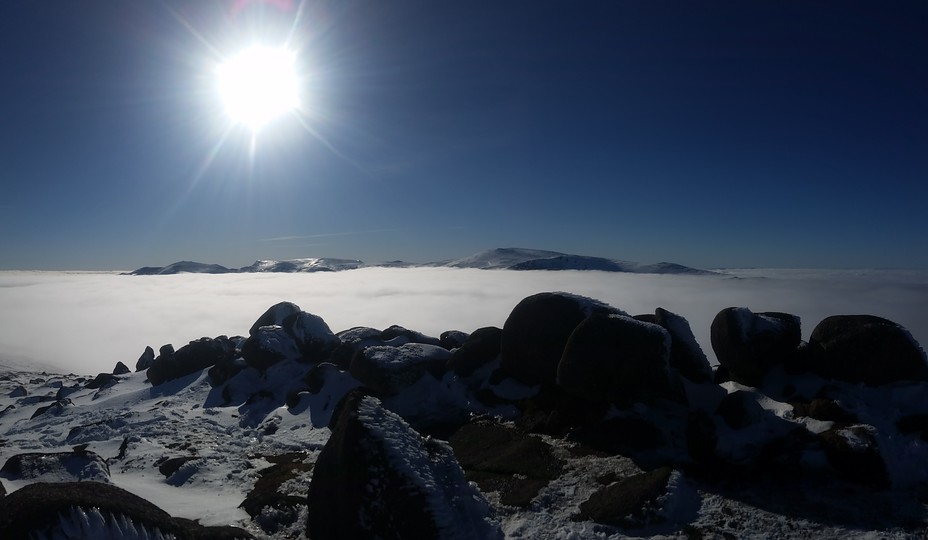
(129, 248, 715, 276)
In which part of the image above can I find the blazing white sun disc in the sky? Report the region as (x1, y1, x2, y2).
(216, 45, 300, 133)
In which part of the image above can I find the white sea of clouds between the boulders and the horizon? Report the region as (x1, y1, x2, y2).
(0, 268, 928, 375)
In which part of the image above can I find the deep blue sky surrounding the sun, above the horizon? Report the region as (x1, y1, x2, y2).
(0, 0, 928, 269)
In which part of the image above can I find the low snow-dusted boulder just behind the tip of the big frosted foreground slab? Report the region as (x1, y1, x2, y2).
(349, 343, 451, 394)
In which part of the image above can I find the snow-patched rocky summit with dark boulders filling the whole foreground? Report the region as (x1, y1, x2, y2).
(0, 298, 928, 540)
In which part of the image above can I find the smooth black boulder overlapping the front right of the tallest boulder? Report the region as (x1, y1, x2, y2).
(557, 314, 673, 404)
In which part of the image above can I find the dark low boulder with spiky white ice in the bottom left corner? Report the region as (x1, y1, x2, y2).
(0, 482, 254, 540)
